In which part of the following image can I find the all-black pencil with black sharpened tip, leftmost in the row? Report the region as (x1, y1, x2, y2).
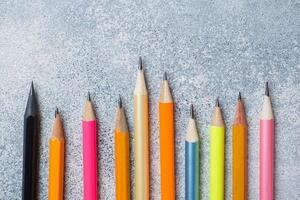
(22, 83, 39, 200)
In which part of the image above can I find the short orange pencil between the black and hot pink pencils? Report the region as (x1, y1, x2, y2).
(48, 109, 65, 200)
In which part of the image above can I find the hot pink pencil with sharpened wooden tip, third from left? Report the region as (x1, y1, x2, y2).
(82, 94, 98, 200)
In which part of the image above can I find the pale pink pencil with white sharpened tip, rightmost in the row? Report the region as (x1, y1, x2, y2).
(259, 82, 274, 200)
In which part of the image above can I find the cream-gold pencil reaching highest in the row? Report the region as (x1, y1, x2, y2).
(134, 57, 149, 200)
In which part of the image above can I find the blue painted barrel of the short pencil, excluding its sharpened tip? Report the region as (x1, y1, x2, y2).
(185, 141, 200, 200)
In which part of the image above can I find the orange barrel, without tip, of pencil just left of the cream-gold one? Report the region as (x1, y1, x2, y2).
(115, 130, 130, 200)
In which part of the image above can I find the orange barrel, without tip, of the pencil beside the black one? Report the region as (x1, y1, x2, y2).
(48, 138, 65, 200)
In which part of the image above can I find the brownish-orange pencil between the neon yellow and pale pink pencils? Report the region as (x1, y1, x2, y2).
(232, 93, 248, 200)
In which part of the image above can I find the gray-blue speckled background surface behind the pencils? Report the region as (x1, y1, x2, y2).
(0, 0, 300, 200)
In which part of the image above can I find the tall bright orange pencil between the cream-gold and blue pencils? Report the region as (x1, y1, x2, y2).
(159, 73, 175, 200)
